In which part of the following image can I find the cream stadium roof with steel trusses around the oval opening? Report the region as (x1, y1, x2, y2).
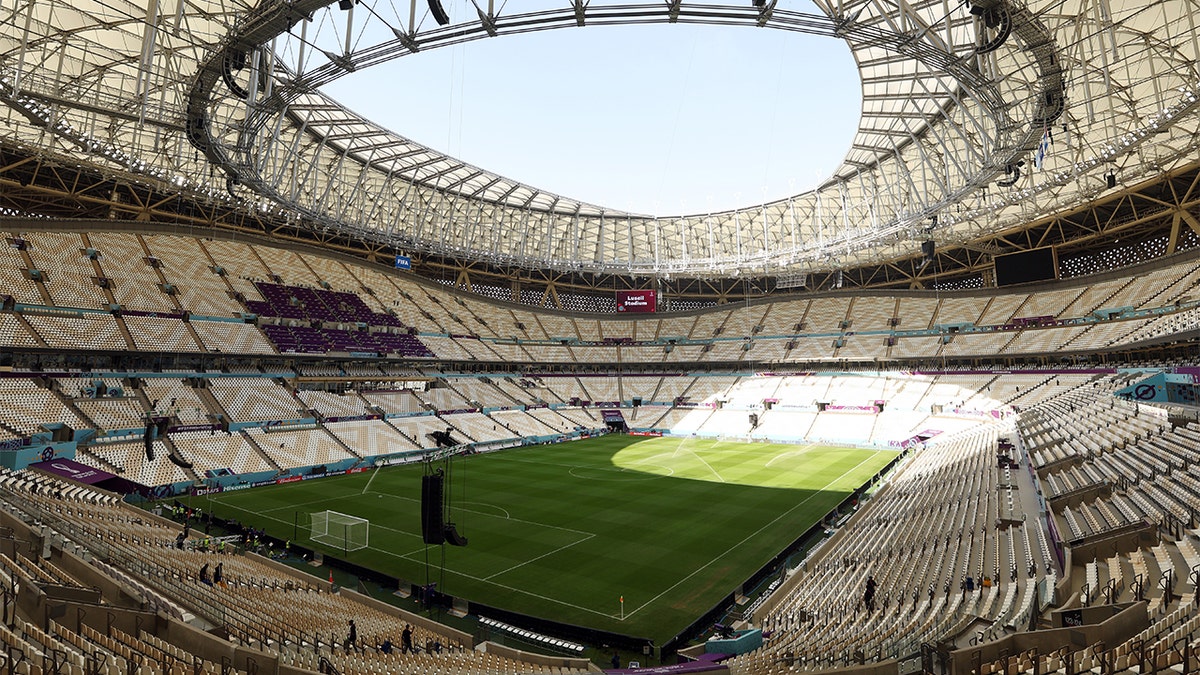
(0, 0, 1200, 276)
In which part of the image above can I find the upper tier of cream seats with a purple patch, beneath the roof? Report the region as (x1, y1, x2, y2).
(0, 225, 1200, 364)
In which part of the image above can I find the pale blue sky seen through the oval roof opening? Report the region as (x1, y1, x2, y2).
(324, 13, 862, 216)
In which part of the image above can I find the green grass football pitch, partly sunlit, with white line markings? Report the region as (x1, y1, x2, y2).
(193, 435, 896, 644)
